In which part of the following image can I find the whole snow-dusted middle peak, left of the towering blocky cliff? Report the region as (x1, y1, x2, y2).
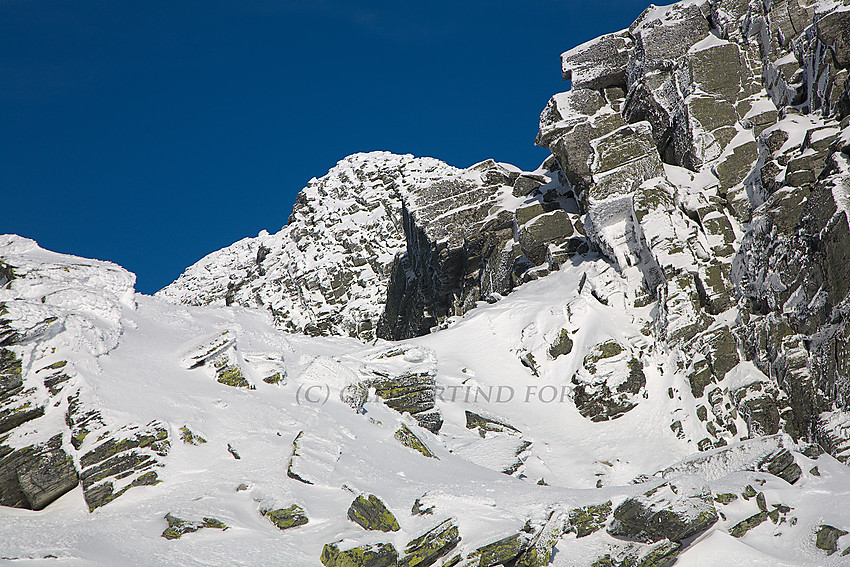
(157, 152, 580, 341)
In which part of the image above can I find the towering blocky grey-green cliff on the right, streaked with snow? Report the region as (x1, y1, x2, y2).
(537, 0, 850, 449)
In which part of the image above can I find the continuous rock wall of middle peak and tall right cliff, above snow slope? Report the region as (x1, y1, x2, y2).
(160, 0, 850, 458)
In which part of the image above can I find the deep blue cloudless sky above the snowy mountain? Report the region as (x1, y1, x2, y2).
(0, 0, 648, 293)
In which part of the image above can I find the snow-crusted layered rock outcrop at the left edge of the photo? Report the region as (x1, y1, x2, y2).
(0, 236, 170, 510)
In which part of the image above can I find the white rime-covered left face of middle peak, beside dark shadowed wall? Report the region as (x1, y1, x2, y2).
(158, 152, 420, 341)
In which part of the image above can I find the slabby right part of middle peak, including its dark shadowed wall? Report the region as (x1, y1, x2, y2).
(378, 160, 587, 340)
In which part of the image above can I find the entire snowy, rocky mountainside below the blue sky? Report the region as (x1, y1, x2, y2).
(0, 0, 850, 567)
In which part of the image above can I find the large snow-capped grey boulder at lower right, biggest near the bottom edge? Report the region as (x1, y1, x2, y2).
(608, 476, 718, 542)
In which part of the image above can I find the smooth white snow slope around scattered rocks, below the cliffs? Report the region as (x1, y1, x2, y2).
(0, 235, 850, 566)
